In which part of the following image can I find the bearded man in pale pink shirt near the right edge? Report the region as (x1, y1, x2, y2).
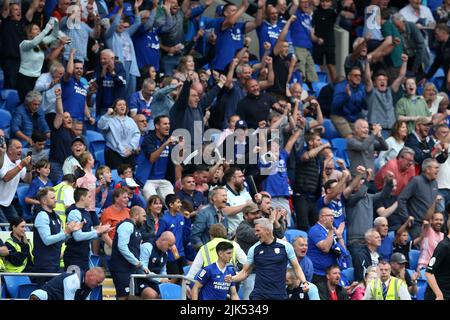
(417, 212, 444, 271)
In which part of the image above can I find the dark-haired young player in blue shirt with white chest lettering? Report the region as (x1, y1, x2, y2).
(192, 241, 239, 300)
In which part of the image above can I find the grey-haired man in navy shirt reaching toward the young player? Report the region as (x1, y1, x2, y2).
(225, 218, 309, 300)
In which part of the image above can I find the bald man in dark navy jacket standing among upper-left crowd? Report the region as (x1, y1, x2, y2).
(94, 49, 127, 115)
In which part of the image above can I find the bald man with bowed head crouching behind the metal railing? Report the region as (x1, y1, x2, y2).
(136, 231, 175, 300)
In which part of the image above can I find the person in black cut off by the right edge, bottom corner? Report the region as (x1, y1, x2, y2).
(426, 236, 450, 300)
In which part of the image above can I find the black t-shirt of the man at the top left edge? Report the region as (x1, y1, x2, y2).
(0, 17, 27, 59)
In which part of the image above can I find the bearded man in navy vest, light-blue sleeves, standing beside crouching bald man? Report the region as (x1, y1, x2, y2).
(111, 206, 150, 300)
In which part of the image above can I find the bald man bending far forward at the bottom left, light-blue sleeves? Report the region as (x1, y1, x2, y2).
(29, 267, 105, 300)
